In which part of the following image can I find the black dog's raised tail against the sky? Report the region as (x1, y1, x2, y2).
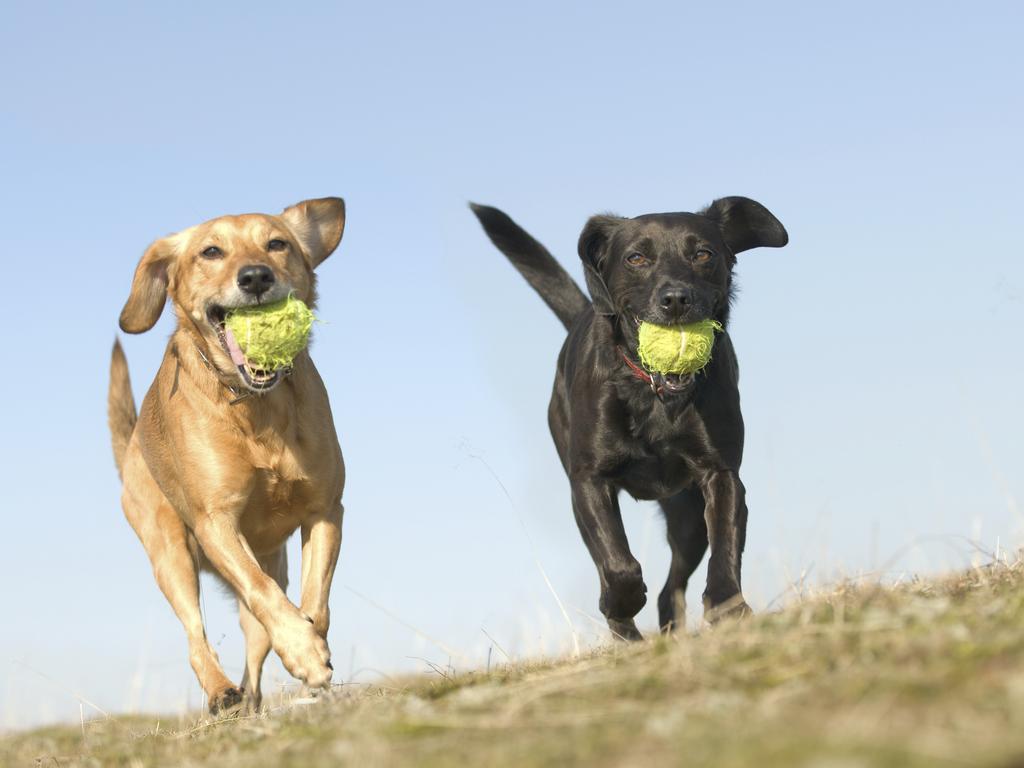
(469, 203, 590, 329)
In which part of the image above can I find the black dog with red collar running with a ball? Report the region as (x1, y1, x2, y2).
(471, 198, 788, 639)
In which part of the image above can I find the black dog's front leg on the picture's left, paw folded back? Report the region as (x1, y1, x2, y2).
(572, 476, 647, 640)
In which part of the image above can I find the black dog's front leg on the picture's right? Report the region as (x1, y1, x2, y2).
(701, 470, 751, 622)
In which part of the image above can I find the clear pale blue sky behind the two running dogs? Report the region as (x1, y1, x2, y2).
(0, 2, 1024, 727)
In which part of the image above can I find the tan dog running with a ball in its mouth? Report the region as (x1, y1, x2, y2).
(109, 198, 345, 713)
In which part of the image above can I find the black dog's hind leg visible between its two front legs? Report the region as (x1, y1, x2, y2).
(657, 487, 708, 632)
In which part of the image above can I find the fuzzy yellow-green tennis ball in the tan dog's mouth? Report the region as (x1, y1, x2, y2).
(224, 296, 313, 371)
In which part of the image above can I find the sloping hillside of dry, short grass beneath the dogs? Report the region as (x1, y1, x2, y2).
(8, 561, 1024, 768)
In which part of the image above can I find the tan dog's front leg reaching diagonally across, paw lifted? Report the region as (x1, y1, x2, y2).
(194, 513, 331, 688)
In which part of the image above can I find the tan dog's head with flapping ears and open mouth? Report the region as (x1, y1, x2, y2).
(121, 198, 345, 392)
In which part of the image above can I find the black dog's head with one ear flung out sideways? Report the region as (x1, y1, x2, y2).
(580, 198, 788, 341)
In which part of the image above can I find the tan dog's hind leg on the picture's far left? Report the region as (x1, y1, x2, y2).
(122, 484, 242, 715)
